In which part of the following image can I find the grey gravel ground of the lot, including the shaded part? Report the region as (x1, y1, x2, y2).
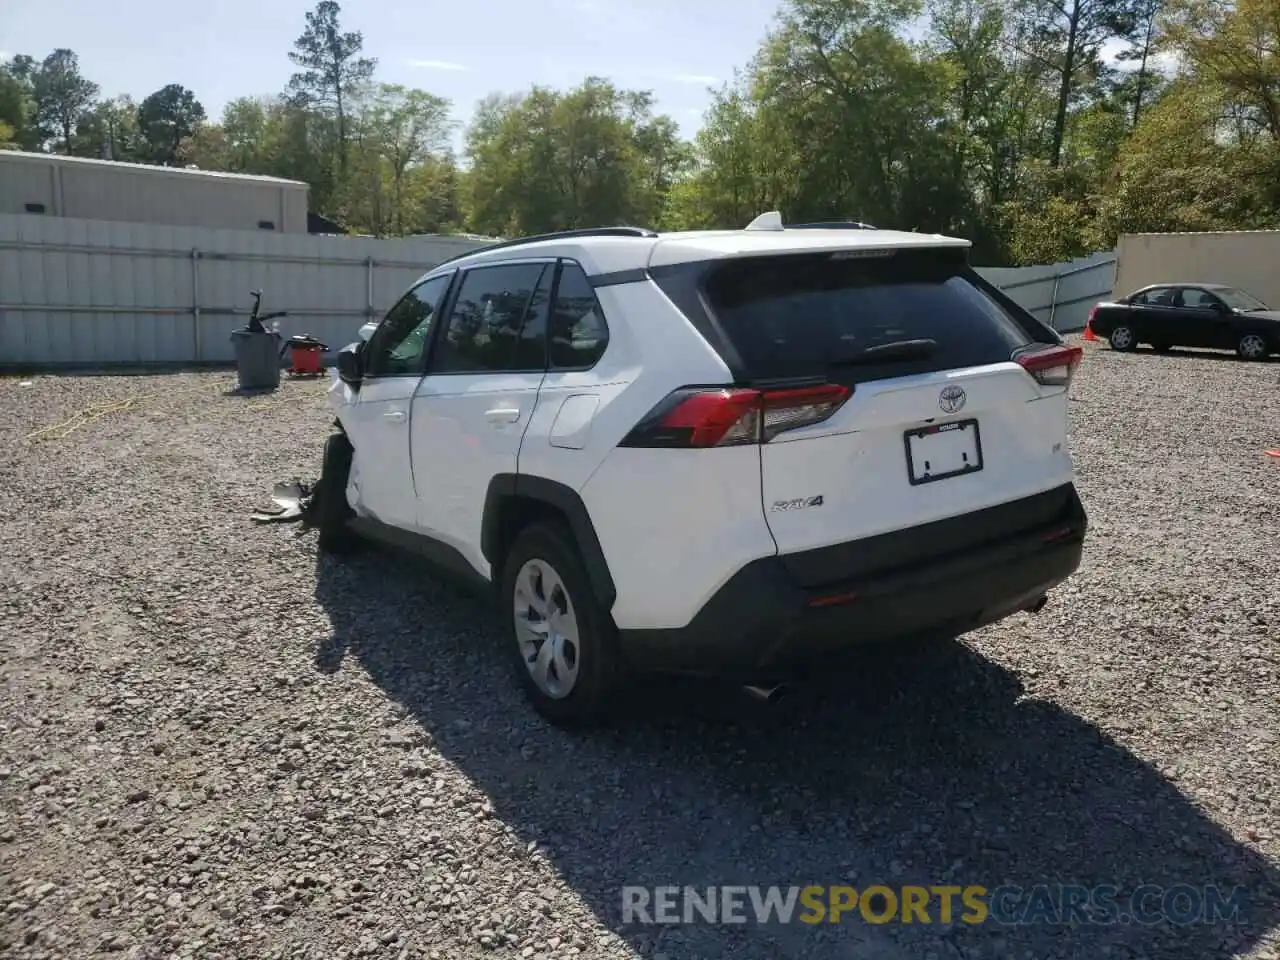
(0, 347, 1280, 960)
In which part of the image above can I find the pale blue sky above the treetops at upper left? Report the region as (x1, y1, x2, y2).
(0, 0, 778, 148)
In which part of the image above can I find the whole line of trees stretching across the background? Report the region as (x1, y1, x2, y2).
(0, 0, 1280, 265)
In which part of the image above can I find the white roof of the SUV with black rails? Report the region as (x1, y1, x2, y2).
(424, 219, 973, 285)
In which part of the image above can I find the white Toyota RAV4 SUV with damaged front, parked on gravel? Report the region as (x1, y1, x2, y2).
(316, 214, 1087, 723)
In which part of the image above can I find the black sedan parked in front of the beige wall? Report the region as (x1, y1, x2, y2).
(1089, 283, 1280, 360)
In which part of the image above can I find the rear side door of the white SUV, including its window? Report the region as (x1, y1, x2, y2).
(410, 261, 554, 577)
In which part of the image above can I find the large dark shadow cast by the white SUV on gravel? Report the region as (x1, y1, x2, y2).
(316, 553, 1280, 960)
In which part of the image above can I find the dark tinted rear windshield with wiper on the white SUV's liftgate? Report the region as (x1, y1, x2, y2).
(705, 251, 1032, 381)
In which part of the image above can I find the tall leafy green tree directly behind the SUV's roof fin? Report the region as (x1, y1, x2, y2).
(750, 0, 966, 230)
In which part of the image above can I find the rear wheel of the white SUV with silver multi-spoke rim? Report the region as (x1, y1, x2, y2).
(499, 522, 622, 727)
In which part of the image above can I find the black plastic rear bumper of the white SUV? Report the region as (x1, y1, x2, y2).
(620, 485, 1088, 682)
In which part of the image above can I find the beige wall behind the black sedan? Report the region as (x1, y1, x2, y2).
(1116, 230, 1280, 307)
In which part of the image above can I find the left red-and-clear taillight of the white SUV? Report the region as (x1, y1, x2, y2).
(621, 384, 852, 448)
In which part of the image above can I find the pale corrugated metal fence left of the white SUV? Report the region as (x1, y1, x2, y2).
(0, 215, 484, 367)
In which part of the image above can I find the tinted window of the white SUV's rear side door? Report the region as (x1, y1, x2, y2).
(431, 264, 549, 374)
